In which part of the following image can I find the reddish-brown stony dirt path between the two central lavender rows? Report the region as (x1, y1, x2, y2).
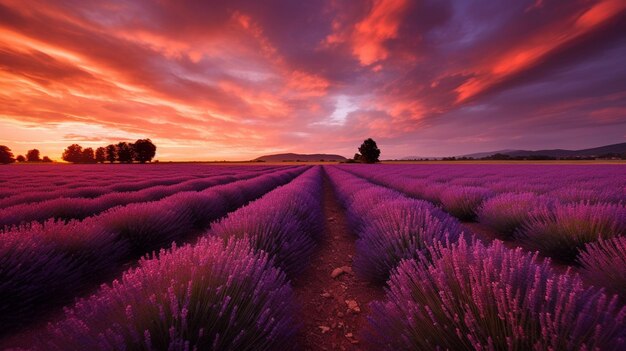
(293, 176, 384, 350)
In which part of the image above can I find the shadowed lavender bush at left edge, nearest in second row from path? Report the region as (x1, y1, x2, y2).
(0, 221, 129, 332)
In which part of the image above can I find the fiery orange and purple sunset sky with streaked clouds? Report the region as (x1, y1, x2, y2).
(0, 0, 626, 160)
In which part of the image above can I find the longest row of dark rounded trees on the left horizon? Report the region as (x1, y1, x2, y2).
(62, 139, 156, 163)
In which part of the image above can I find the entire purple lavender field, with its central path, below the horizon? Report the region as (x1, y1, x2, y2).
(0, 164, 626, 350)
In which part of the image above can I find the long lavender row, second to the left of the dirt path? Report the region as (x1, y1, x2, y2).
(0, 167, 305, 332)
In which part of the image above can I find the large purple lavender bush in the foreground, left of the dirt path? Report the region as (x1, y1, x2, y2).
(37, 238, 297, 350)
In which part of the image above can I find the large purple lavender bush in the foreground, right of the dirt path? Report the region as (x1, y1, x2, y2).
(366, 240, 626, 350)
